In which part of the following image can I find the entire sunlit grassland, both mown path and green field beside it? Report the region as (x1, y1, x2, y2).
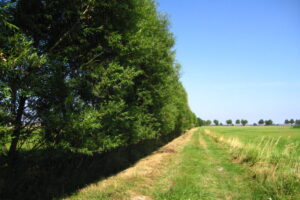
(66, 126, 300, 200)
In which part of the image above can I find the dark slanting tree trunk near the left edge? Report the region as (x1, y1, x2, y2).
(8, 97, 26, 165)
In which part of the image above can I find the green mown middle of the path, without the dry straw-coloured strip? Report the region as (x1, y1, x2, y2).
(154, 129, 269, 200)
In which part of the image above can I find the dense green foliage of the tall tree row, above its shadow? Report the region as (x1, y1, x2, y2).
(0, 0, 197, 159)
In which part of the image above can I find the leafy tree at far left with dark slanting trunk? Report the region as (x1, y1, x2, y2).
(0, 10, 46, 162)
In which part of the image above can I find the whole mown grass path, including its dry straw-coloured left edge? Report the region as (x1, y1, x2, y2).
(63, 128, 270, 200)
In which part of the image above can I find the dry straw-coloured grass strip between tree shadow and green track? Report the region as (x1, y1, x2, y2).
(65, 128, 197, 200)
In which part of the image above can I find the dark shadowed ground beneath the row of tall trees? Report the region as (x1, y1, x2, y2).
(0, 133, 179, 200)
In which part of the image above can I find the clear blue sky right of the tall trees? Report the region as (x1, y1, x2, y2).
(157, 0, 300, 123)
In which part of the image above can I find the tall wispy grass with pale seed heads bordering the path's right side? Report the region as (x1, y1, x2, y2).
(205, 130, 300, 199)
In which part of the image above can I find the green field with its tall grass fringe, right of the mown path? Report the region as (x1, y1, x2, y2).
(207, 126, 300, 199)
